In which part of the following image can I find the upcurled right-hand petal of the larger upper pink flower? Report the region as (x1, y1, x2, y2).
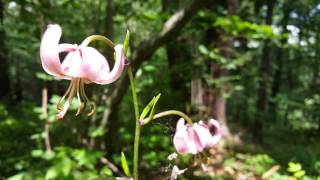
(93, 44, 125, 84)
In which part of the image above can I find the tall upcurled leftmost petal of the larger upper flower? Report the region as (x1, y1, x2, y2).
(40, 24, 63, 77)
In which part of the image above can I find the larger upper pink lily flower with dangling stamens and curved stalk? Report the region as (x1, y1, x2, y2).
(40, 24, 126, 120)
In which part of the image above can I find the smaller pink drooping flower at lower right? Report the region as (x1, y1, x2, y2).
(173, 118, 221, 154)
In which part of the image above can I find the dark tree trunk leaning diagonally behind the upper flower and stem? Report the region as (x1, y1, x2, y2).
(102, 0, 208, 145)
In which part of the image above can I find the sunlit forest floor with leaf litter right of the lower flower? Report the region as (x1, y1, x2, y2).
(190, 129, 320, 180)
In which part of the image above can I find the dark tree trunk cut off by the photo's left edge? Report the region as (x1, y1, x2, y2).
(0, 0, 10, 99)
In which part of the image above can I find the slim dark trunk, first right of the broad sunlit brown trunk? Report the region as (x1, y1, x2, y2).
(252, 0, 275, 144)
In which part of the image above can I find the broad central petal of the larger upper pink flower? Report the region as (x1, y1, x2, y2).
(79, 47, 110, 82)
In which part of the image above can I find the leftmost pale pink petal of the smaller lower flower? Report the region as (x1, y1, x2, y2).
(173, 118, 197, 154)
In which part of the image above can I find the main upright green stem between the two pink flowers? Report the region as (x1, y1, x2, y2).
(128, 67, 140, 180)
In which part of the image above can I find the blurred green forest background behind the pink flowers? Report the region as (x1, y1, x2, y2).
(0, 0, 320, 180)
